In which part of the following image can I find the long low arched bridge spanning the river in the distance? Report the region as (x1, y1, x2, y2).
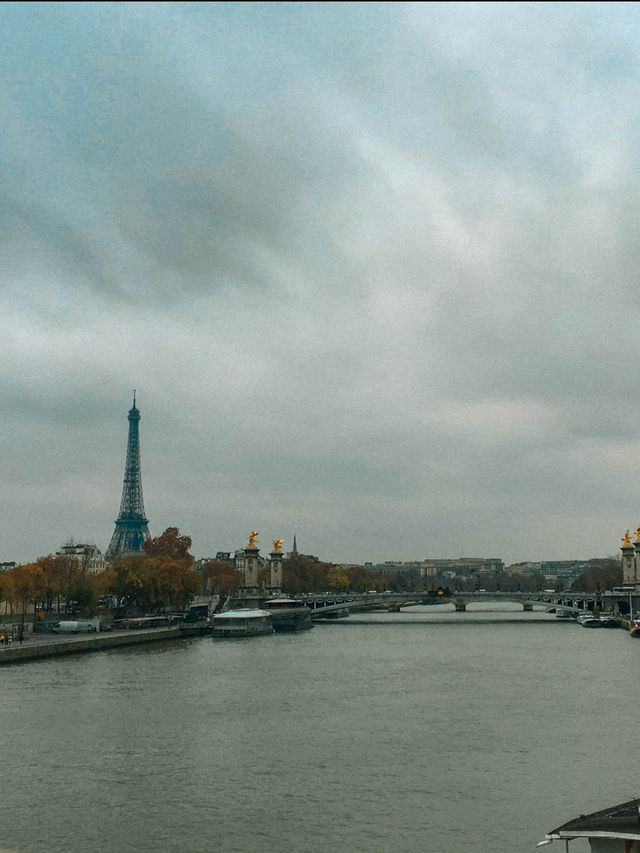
(296, 590, 624, 619)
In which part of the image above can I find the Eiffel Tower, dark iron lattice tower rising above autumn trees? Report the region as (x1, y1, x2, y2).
(104, 391, 150, 560)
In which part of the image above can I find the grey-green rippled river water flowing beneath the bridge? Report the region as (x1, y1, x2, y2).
(0, 608, 640, 853)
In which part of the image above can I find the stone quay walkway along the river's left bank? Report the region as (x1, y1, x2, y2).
(0, 625, 184, 665)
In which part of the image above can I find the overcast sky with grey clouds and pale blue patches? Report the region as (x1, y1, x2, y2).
(0, 3, 640, 563)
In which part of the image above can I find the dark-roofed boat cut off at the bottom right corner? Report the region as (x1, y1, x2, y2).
(536, 800, 640, 853)
